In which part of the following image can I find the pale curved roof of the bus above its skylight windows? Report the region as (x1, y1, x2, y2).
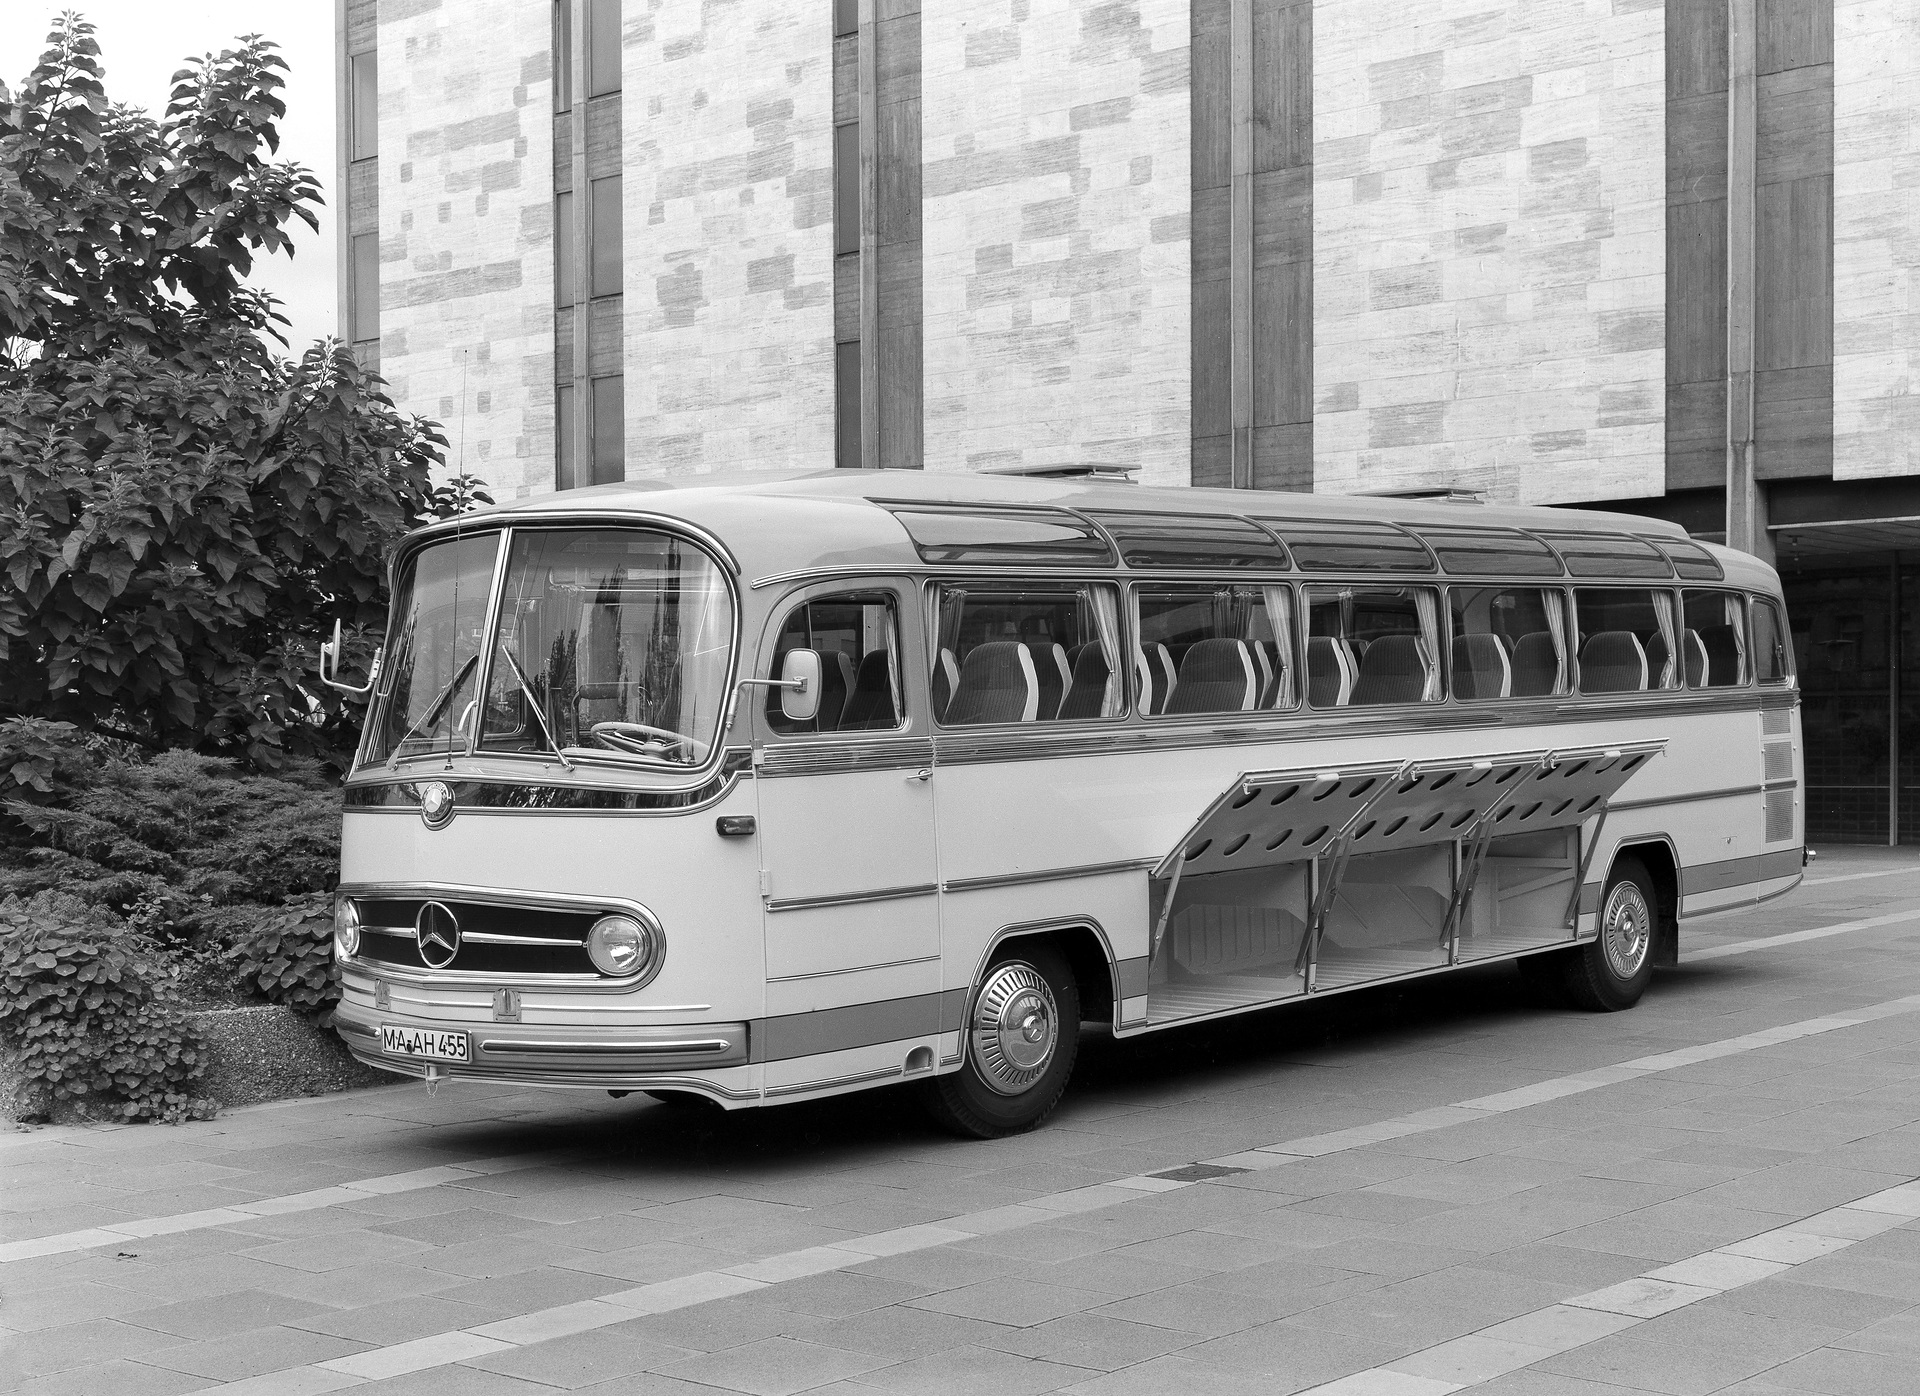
(420, 470, 1778, 590)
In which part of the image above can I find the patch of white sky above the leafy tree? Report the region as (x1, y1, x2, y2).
(0, 0, 338, 353)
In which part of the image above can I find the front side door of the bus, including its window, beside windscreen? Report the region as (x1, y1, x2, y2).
(749, 582, 941, 1059)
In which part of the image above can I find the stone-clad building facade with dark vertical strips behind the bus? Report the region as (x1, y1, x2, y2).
(336, 0, 1920, 841)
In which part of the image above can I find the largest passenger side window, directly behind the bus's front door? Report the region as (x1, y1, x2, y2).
(927, 582, 1127, 728)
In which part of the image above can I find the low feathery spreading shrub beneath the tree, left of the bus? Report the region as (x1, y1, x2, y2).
(0, 720, 340, 941)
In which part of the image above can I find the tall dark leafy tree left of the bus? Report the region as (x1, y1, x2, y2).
(0, 13, 480, 780)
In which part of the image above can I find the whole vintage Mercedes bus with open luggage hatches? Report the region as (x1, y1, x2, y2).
(323, 470, 1803, 1137)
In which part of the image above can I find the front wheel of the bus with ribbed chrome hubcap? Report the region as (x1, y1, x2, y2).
(922, 941, 1079, 1139)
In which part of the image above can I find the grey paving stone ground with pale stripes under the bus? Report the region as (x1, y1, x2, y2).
(0, 849, 1920, 1396)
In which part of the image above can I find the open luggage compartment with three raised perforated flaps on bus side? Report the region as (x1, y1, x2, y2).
(1148, 741, 1667, 1022)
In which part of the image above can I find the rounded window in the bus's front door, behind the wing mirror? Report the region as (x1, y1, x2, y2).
(766, 591, 902, 735)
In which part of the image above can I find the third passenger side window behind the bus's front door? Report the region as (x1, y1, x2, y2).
(1306, 586, 1442, 709)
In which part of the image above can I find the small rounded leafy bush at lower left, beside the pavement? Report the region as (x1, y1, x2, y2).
(0, 893, 217, 1123)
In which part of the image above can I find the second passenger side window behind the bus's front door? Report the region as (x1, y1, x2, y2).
(1133, 584, 1300, 718)
